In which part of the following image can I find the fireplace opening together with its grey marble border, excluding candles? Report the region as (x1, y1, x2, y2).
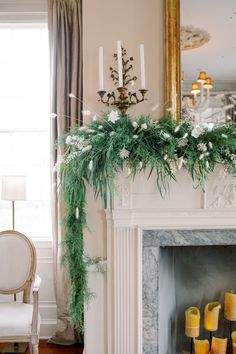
(142, 230, 236, 354)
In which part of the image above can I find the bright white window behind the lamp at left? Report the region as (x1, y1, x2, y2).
(0, 24, 51, 239)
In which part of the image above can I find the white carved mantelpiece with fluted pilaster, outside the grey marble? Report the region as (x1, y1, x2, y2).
(104, 170, 236, 354)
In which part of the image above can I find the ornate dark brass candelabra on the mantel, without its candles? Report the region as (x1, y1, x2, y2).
(98, 47, 148, 115)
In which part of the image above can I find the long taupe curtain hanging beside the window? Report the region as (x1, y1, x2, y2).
(48, 0, 82, 345)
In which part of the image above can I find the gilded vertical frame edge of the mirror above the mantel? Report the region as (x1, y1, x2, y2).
(164, 0, 181, 120)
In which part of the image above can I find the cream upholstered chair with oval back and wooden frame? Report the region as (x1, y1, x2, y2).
(0, 230, 41, 354)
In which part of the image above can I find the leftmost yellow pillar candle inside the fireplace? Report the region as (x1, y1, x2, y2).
(185, 307, 200, 338)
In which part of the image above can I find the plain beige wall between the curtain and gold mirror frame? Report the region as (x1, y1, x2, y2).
(83, 0, 164, 258)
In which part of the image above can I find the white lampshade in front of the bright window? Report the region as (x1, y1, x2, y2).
(2, 176, 26, 200)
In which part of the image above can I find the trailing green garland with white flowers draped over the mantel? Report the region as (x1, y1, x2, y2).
(60, 111, 236, 329)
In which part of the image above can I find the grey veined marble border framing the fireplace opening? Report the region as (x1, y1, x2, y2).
(143, 229, 236, 354)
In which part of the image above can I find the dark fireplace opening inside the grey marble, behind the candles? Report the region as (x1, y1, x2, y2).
(157, 245, 236, 354)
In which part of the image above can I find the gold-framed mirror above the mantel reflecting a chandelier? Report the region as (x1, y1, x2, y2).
(165, 0, 236, 124)
